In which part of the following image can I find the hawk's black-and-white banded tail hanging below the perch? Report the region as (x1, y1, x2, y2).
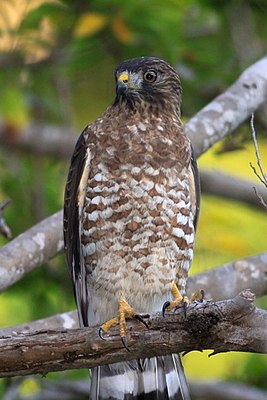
(90, 354, 190, 400)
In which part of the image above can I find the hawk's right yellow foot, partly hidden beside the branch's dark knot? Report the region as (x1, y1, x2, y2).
(162, 281, 204, 317)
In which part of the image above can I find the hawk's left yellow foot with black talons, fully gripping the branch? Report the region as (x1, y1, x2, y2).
(99, 296, 149, 351)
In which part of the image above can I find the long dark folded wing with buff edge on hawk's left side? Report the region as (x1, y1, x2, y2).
(64, 127, 90, 326)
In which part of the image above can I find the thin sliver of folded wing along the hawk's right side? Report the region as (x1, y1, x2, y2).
(189, 145, 200, 231)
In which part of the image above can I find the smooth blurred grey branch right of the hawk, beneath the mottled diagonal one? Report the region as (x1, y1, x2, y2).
(200, 170, 267, 207)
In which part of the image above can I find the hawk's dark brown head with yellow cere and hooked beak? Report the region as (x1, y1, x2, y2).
(114, 57, 182, 116)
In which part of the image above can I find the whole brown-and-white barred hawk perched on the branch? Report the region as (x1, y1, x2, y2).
(64, 57, 199, 400)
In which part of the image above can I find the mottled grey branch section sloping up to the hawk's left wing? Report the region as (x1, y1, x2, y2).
(0, 211, 63, 291)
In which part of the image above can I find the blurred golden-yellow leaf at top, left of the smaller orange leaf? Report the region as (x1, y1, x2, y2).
(74, 12, 108, 37)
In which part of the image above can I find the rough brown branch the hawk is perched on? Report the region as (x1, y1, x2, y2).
(0, 290, 267, 377)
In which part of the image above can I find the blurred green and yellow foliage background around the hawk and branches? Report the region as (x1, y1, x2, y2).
(0, 0, 267, 398)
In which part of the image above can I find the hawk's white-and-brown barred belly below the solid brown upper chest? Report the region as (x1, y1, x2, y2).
(82, 166, 194, 325)
